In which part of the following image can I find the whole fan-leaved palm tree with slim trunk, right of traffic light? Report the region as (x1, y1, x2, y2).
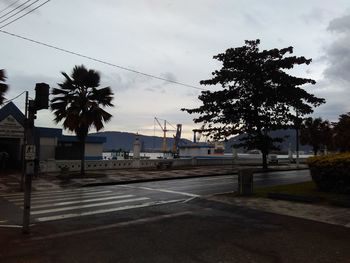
(51, 65, 113, 176)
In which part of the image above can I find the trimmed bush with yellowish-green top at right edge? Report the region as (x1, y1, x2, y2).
(307, 153, 350, 193)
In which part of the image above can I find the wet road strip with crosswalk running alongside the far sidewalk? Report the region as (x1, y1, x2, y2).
(0, 170, 310, 226)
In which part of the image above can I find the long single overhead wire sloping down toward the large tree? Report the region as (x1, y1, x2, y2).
(0, 29, 206, 91)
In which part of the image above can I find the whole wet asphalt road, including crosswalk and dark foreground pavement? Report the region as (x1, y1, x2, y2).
(0, 171, 350, 263)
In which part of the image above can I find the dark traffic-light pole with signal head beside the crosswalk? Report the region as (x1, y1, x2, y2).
(22, 83, 50, 234)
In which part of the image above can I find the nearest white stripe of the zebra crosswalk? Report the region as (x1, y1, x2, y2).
(35, 200, 182, 222)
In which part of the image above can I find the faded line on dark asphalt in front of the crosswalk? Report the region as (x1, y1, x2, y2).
(29, 211, 193, 242)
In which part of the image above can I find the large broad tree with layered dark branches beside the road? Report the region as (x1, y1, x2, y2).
(183, 40, 325, 168)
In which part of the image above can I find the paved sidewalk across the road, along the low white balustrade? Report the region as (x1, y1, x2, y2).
(0, 165, 307, 193)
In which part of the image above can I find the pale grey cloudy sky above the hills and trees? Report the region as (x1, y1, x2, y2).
(0, 0, 350, 139)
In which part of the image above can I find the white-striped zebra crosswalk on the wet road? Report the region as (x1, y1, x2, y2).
(0, 187, 178, 222)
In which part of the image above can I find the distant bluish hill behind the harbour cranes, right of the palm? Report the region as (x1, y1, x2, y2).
(91, 131, 190, 151)
